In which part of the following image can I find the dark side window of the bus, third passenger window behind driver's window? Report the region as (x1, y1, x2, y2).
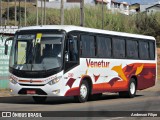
(113, 38, 125, 58)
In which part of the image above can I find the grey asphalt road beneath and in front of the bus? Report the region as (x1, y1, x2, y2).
(0, 81, 160, 120)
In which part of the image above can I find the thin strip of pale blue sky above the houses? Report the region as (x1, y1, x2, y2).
(116, 0, 160, 4)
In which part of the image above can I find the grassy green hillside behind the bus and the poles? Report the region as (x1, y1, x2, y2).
(0, 3, 160, 46)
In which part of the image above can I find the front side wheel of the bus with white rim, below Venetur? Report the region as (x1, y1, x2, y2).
(74, 80, 89, 103)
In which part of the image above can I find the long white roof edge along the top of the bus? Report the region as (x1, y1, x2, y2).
(19, 25, 155, 40)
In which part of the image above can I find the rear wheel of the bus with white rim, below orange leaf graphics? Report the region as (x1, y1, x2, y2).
(119, 78, 136, 98)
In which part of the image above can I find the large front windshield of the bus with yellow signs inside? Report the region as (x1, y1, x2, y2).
(10, 33, 64, 71)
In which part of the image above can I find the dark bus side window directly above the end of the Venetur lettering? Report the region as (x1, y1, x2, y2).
(97, 37, 111, 57)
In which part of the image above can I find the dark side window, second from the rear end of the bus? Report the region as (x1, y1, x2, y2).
(139, 41, 149, 60)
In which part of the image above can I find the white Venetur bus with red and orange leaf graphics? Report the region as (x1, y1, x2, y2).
(6, 25, 157, 102)
